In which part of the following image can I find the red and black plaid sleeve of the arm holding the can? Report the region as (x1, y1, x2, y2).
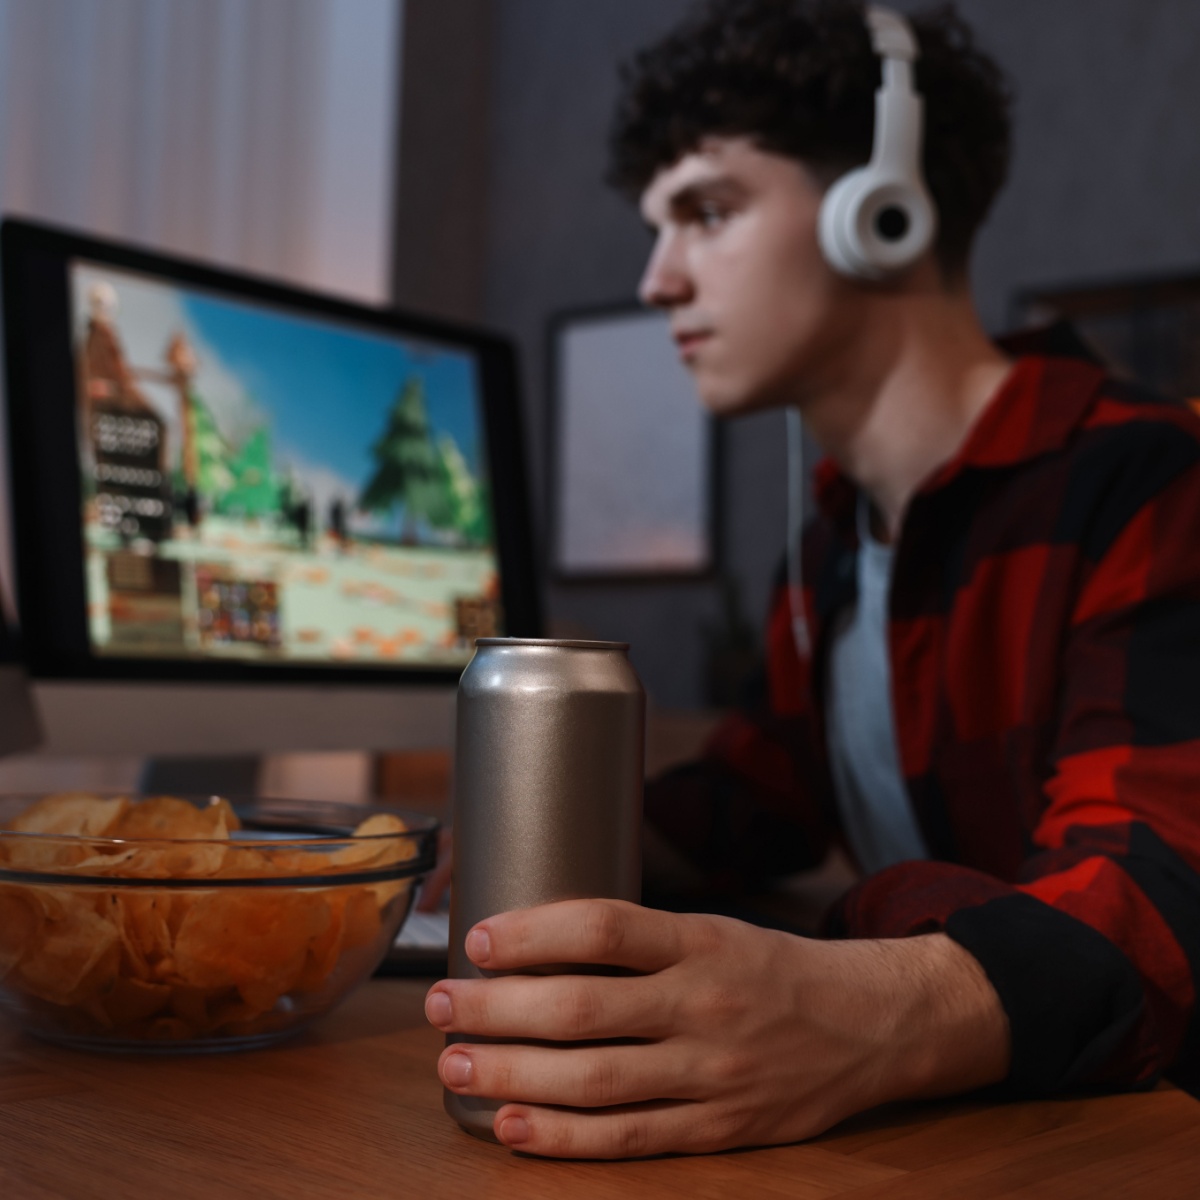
(830, 381, 1200, 1096)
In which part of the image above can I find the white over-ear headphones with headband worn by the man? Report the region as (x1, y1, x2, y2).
(817, 5, 937, 282)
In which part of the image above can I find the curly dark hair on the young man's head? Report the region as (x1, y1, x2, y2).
(608, 0, 1012, 276)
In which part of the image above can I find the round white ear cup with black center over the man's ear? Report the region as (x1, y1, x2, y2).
(817, 166, 937, 282)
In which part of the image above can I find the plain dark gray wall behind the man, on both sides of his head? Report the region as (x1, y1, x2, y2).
(398, 0, 1200, 706)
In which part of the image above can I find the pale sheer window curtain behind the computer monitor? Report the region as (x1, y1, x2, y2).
(0, 0, 403, 790)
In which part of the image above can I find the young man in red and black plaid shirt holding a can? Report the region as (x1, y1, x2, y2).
(427, 0, 1200, 1157)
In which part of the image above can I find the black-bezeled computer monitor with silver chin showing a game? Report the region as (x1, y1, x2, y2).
(0, 220, 539, 755)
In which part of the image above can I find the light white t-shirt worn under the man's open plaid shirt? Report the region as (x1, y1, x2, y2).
(826, 500, 929, 874)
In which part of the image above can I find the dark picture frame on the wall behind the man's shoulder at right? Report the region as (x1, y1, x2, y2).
(1013, 270, 1200, 407)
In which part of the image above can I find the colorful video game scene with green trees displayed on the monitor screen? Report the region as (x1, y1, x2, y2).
(71, 262, 503, 666)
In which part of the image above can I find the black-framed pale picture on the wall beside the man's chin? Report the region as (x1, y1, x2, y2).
(548, 304, 719, 582)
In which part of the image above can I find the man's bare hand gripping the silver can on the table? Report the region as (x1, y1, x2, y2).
(425, 900, 1009, 1158)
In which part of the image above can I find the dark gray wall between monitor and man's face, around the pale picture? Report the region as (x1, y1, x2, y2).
(485, 0, 785, 707)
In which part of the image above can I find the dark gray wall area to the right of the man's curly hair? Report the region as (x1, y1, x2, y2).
(961, 0, 1200, 326)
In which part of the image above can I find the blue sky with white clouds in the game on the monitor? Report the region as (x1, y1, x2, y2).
(71, 260, 485, 534)
